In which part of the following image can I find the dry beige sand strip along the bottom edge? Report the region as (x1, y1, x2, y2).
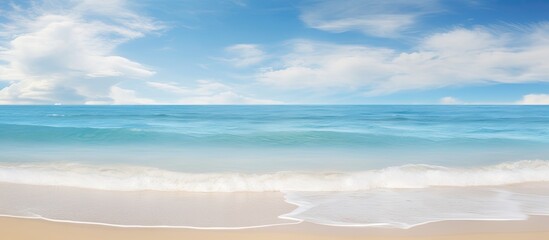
(0, 217, 549, 240)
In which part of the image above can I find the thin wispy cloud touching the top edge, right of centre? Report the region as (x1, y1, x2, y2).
(301, 0, 438, 37)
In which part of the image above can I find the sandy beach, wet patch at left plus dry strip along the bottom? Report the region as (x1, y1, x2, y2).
(0, 183, 549, 240)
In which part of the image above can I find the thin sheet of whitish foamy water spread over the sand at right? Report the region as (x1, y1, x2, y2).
(281, 184, 549, 229)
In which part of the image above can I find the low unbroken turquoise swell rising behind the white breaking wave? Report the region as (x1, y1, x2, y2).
(0, 123, 539, 147)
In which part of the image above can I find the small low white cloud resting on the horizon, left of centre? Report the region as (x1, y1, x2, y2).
(147, 80, 280, 104)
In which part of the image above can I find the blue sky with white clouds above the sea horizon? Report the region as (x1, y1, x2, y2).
(0, 0, 549, 104)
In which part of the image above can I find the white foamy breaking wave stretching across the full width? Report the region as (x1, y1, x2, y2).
(0, 160, 549, 192)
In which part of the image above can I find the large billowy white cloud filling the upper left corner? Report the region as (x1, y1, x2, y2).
(0, 0, 160, 104)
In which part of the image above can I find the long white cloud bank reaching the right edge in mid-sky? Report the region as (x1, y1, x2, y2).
(257, 23, 549, 95)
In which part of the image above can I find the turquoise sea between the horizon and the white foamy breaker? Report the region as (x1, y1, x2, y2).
(0, 106, 549, 172)
